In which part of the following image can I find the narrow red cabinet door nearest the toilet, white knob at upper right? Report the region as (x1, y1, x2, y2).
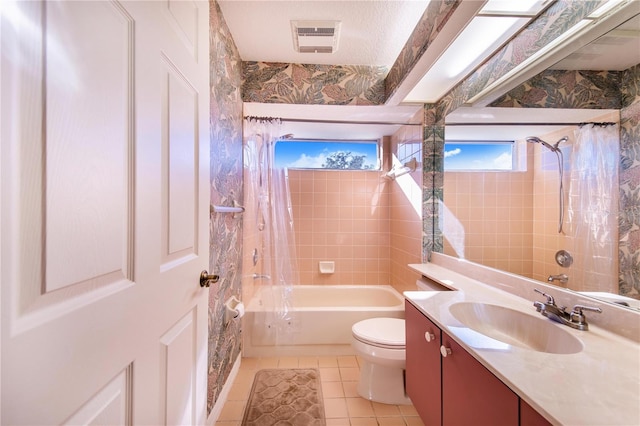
(405, 301, 442, 425)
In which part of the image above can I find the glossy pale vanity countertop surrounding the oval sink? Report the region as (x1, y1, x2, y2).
(404, 263, 640, 426)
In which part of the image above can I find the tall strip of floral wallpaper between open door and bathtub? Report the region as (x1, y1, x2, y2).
(207, 0, 243, 413)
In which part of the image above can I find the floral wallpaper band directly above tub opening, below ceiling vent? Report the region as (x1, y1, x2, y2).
(242, 62, 387, 105)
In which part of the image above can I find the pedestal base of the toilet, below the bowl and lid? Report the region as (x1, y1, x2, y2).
(358, 361, 411, 405)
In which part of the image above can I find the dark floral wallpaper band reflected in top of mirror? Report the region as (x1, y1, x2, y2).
(490, 70, 622, 109)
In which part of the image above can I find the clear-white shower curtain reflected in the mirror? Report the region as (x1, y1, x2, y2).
(567, 124, 620, 294)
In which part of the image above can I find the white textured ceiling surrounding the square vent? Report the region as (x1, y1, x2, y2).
(218, 0, 429, 68)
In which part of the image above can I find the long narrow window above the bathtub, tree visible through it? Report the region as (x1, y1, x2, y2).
(275, 139, 380, 170)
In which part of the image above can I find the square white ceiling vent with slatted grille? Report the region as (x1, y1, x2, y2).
(291, 21, 340, 53)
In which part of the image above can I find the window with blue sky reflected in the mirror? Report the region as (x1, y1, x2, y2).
(444, 141, 516, 171)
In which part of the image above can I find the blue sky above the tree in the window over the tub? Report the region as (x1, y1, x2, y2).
(275, 140, 378, 169)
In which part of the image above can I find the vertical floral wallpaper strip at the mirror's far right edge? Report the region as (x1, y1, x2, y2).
(618, 64, 640, 298)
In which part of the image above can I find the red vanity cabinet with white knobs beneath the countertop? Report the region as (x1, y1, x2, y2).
(405, 301, 536, 426)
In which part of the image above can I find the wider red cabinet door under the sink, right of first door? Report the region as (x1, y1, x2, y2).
(442, 333, 519, 426)
